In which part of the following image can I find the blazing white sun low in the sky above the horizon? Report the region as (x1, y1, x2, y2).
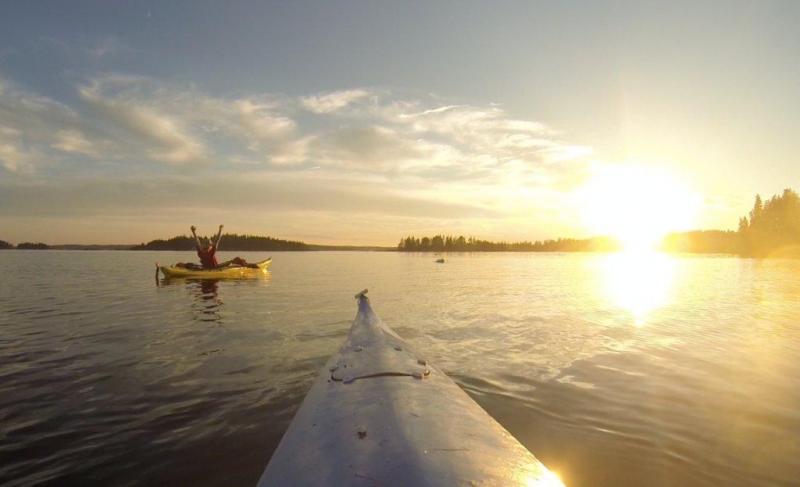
(578, 165, 699, 251)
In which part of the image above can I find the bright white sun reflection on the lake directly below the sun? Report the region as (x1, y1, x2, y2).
(600, 250, 675, 326)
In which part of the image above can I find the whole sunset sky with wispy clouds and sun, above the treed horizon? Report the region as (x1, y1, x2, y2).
(0, 1, 800, 245)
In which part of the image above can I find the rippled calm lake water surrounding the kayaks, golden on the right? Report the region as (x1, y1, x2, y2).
(0, 251, 800, 486)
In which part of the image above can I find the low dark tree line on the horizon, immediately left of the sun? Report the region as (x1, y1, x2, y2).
(397, 235, 619, 252)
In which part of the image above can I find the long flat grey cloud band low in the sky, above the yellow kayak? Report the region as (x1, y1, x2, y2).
(0, 173, 495, 218)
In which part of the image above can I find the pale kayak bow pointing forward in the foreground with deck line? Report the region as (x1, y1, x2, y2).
(258, 290, 563, 487)
